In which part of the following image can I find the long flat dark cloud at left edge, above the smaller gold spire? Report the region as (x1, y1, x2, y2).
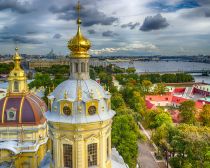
(0, 35, 42, 44)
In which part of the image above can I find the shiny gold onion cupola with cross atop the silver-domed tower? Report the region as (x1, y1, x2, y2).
(68, 2, 91, 58)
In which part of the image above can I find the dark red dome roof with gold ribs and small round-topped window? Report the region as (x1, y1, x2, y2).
(0, 93, 47, 126)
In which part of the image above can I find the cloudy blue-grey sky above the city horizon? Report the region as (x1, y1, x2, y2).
(0, 0, 210, 56)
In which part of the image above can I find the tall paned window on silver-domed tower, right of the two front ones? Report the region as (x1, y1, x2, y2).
(88, 143, 97, 167)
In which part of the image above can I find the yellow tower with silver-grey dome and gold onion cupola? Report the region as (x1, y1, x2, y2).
(46, 3, 126, 168)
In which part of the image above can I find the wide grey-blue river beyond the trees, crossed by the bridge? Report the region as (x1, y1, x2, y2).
(114, 61, 210, 84)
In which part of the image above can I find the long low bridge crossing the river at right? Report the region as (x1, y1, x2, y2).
(138, 69, 210, 76)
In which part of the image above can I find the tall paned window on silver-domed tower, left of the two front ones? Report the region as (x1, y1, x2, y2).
(63, 144, 73, 168)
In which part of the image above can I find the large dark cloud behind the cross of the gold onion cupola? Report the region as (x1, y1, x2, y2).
(49, 4, 118, 27)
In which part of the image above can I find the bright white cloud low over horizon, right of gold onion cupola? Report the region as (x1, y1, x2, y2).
(90, 42, 158, 55)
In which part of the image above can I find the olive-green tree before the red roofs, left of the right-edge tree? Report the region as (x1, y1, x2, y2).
(179, 100, 196, 124)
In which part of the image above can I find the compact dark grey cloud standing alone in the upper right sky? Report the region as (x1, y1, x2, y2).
(140, 14, 169, 31)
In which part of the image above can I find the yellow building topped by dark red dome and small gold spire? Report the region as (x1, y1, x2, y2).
(0, 48, 48, 168)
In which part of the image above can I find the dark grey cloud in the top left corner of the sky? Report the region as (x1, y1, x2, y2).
(0, 0, 34, 14)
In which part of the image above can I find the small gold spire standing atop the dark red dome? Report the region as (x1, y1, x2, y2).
(8, 47, 28, 94)
